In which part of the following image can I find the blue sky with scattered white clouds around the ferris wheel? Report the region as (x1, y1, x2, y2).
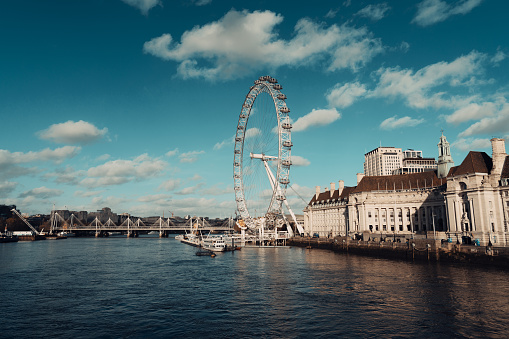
(0, 0, 509, 217)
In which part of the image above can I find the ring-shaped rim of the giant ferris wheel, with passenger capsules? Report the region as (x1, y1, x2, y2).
(233, 76, 293, 229)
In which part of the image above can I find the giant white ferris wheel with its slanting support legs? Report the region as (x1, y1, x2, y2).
(233, 76, 304, 235)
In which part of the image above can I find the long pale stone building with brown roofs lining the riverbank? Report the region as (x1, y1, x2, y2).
(304, 134, 509, 246)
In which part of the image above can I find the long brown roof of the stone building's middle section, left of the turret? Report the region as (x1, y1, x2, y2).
(352, 171, 446, 193)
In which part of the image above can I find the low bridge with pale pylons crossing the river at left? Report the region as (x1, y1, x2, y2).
(51, 212, 233, 235)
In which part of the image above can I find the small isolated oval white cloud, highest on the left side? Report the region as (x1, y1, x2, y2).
(38, 120, 108, 144)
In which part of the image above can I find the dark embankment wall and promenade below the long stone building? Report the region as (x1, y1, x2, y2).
(288, 237, 509, 269)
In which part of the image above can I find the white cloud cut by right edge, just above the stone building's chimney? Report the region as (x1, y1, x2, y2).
(458, 101, 509, 138)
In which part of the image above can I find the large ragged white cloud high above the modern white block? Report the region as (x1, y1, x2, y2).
(369, 51, 486, 108)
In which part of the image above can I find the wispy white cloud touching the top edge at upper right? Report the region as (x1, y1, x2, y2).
(412, 0, 482, 26)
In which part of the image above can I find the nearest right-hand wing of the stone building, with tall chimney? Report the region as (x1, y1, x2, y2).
(444, 138, 509, 245)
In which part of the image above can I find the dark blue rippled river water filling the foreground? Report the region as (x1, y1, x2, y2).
(0, 237, 509, 338)
